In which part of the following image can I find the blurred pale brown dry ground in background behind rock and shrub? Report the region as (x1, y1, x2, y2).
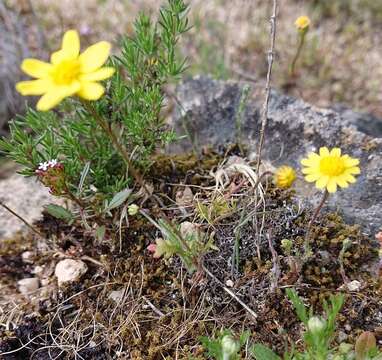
(9, 0, 382, 117)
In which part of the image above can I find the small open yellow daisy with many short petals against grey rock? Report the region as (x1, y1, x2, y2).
(301, 147, 360, 193)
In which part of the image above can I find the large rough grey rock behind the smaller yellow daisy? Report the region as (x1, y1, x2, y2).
(170, 77, 382, 235)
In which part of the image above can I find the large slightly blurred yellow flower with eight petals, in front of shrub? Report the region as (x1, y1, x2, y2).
(16, 30, 114, 111)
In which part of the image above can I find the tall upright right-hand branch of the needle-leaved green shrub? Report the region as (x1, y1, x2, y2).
(113, 0, 189, 165)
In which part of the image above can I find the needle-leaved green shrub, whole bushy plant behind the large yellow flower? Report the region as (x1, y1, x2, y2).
(0, 0, 189, 228)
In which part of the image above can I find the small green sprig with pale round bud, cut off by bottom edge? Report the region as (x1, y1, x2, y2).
(200, 330, 250, 360)
